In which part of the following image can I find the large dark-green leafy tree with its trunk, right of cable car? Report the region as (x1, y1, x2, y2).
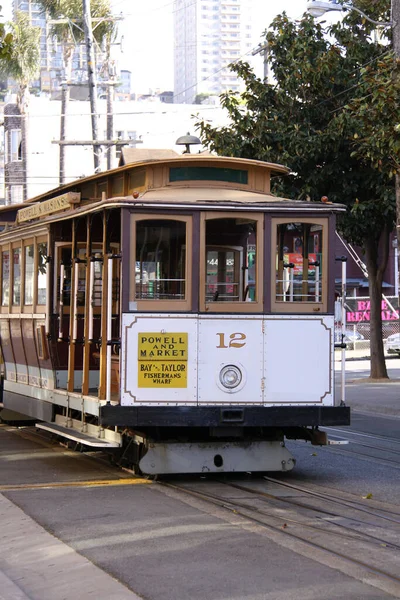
(198, 0, 399, 379)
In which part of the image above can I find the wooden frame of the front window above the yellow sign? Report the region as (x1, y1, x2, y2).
(129, 212, 193, 312)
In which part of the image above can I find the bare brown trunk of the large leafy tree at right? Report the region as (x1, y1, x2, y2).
(364, 227, 389, 379)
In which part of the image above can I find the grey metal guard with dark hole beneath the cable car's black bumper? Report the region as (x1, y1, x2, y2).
(139, 442, 295, 475)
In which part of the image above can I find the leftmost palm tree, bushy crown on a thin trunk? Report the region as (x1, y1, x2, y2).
(0, 11, 40, 200)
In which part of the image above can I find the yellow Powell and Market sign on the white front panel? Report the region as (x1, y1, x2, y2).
(138, 332, 188, 388)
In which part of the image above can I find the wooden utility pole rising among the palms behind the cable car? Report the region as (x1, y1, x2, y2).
(83, 0, 101, 172)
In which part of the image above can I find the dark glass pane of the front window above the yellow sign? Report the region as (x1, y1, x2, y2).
(135, 219, 186, 300)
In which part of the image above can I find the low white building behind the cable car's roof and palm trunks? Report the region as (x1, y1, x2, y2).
(4, 97, 231, 204)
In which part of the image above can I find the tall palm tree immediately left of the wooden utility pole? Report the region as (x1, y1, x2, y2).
(38, 0, 115, 185)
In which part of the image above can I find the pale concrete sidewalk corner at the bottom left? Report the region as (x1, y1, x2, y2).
(0, 494, 140, 600)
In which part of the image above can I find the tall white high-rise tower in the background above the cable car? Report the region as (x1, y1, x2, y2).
(174, 0, 253, 104)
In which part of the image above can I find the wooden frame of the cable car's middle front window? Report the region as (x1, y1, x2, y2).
(199, 211, 264, 313)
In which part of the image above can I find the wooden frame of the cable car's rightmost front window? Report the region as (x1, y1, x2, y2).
(270, 215, 329, 314)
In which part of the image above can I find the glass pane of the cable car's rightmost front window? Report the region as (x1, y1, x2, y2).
(276, 223, 324, 302)
